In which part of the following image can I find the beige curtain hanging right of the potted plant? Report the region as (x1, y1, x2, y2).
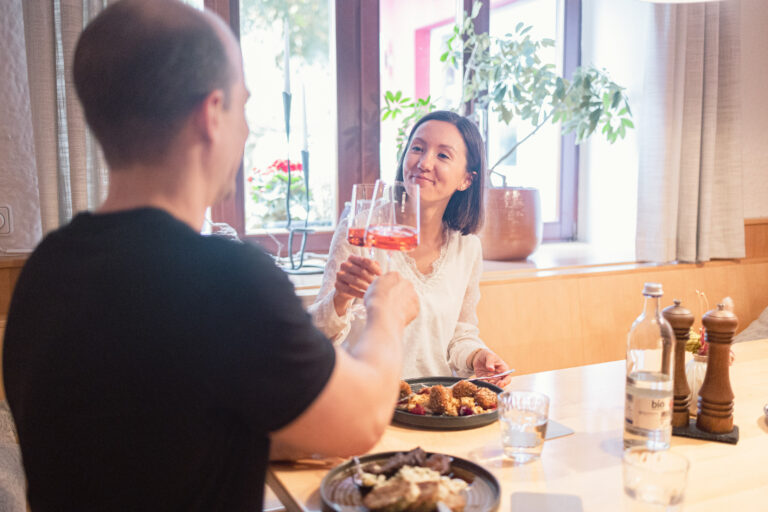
(636, 1, 744, 262)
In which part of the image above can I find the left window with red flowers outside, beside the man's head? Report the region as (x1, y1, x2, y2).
(205, 0, 378, 255)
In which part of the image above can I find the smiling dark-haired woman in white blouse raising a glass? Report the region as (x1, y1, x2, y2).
(309, 111, 511, 386)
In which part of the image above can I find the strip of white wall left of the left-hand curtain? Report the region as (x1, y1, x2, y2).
(0, 0, 41, 250)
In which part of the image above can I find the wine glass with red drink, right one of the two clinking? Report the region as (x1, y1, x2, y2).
(365, 180, 420, 271)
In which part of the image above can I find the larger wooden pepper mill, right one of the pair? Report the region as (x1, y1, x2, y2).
(696, 304, 739, 434)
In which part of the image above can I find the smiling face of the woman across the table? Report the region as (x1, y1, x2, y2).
(403, 120, 472, 205)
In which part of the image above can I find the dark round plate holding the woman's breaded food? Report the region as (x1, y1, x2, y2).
(392, 377, 503, 430)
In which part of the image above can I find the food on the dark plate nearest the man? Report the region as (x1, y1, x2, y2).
(362, 448, 469, 512)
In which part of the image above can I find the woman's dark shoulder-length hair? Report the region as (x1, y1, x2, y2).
(395, 110, 486, 235)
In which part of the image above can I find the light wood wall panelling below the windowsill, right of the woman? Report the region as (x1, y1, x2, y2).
(478, 258, 768, 374)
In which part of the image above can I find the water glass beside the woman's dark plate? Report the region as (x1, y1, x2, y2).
(498, 390, 549, 464)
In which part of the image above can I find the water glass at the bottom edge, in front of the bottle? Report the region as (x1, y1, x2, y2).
(622, 446, 690, 512)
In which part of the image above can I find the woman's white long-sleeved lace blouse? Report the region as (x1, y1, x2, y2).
(309, 221, 485, 378)
